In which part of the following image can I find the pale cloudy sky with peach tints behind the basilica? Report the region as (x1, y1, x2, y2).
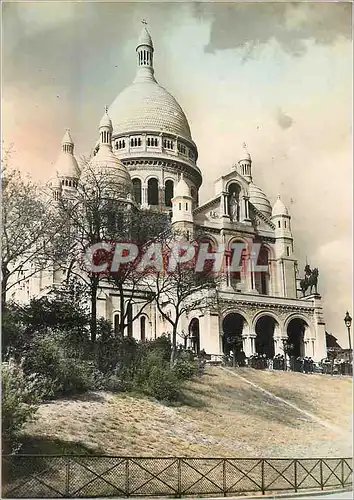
(2, 1, 353, 347)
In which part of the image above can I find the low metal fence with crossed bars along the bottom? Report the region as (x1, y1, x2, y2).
(2, 455, 353, 498)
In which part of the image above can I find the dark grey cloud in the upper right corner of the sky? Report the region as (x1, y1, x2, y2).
(205, 2, 352, 56)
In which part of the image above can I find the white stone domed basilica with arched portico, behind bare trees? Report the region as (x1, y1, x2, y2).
(20, 26, 326, 361)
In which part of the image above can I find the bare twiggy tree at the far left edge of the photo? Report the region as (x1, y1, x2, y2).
(1, 153, 62, 304)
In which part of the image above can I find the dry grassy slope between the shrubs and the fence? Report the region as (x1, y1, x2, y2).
(23, 367, 352, 457)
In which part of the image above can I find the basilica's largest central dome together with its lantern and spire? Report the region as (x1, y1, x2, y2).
(109, 28, 192, 141)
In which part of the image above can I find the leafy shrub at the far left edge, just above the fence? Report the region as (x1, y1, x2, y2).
(1, 359, 43, 452)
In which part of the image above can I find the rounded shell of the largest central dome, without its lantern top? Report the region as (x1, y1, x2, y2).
(109, 78, 192, 141)
